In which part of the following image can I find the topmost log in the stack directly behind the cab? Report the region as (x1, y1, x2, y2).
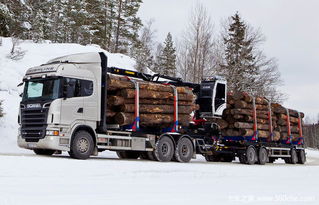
(107, 75, 193, 95)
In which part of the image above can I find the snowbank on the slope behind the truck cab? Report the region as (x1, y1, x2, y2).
(0, 38, 135, 152)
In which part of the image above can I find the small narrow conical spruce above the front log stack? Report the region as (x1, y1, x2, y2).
(159, 33, 176, 76)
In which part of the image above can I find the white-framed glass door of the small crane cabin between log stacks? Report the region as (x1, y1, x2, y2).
(213, 81, 227, 116)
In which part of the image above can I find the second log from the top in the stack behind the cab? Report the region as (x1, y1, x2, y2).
(120, 89, 195, 101)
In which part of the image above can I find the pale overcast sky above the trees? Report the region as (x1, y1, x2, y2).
(139, 0, 319, 119)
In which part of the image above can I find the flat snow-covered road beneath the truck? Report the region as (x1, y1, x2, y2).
(0, 151, 319, 205)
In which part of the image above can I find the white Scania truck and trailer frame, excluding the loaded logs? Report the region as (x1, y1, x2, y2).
(18, 52, 306, 164)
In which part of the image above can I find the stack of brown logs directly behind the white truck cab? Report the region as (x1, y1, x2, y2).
(107, 74, 198, 127)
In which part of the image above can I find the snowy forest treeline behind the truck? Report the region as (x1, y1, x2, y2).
(0, 0, 283, 101)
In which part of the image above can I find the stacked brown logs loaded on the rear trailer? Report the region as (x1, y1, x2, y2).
(220, 92, 304, 141)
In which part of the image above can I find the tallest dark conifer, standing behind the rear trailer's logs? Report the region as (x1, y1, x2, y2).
(221, 13, 258, 92)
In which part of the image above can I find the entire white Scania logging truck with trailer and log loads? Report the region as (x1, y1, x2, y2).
(18, 52, 306, 164)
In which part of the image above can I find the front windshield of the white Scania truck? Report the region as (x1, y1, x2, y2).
(22, 78, 61, 101)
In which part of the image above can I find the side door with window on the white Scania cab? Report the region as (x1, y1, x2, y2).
(60, 78, 84, 126)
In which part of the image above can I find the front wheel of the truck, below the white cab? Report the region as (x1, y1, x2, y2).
(69, 130, 94, 159)
